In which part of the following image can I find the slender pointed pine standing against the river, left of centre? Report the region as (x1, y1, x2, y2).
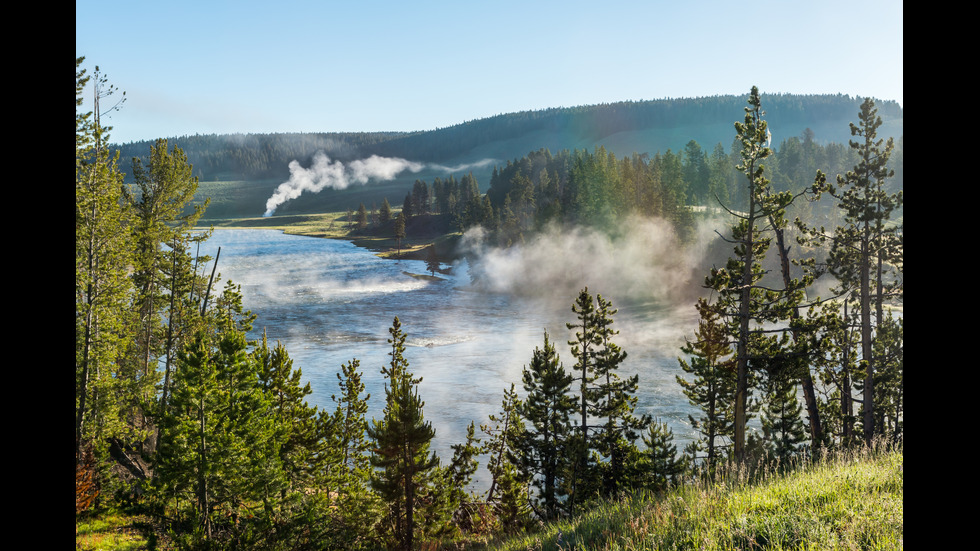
(368, 317, 439, 551)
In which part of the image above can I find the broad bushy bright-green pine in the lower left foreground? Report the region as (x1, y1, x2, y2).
(155, 283, 283, 541)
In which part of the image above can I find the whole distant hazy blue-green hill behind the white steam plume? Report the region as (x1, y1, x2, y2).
(116, 94, 904, 219)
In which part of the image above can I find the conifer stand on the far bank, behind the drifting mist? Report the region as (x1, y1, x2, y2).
(380, 125, 904, 254)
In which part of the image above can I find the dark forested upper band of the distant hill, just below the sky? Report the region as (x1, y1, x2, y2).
(111, 94, 901, 181)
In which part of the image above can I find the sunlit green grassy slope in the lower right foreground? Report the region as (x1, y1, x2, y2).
(487, 451, 903, 551)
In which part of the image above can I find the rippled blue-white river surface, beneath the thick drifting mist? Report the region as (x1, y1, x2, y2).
(201, 230, 696, 488)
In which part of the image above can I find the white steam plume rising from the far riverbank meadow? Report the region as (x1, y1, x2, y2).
(263, 151, 494, 220)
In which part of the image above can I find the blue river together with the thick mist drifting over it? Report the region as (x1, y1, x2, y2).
(201, 229, 703, 490)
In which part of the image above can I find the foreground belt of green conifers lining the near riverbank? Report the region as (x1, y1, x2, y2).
(75, 54, 903, 549)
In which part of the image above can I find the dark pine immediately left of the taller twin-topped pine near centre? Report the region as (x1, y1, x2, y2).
(520, 331, 575, 519)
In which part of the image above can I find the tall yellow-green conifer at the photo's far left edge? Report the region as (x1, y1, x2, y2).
(75, 58, 138, 489)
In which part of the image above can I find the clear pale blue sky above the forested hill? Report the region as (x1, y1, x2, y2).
(75, 0, 904, 143)
